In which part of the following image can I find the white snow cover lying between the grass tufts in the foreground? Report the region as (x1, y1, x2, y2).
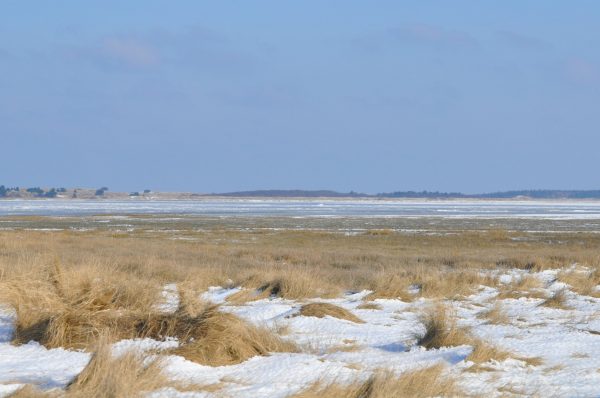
(0, 270, 600, 398)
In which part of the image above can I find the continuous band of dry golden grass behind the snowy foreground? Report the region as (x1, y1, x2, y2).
(0, 226, 600, 305)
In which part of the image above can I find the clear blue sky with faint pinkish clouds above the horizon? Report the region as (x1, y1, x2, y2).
(0, 0, 600, 193)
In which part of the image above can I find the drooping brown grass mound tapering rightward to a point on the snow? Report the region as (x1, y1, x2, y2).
(138, 306, 297, 366)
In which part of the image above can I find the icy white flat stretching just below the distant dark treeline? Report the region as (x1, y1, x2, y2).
(0, 199, 600, 220)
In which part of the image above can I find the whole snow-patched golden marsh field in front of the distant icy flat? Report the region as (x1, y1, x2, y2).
(0, 215, 600, 398)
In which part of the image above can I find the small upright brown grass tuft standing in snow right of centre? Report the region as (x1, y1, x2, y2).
(417, 304, 471, 349)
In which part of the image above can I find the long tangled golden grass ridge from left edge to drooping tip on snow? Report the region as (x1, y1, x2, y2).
(0, 250, 296, 365)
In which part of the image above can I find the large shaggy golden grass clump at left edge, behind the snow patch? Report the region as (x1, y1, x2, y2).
(0, 262, 158, 349)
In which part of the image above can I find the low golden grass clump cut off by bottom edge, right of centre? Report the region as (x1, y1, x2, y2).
(294, 364, 463, 398)
